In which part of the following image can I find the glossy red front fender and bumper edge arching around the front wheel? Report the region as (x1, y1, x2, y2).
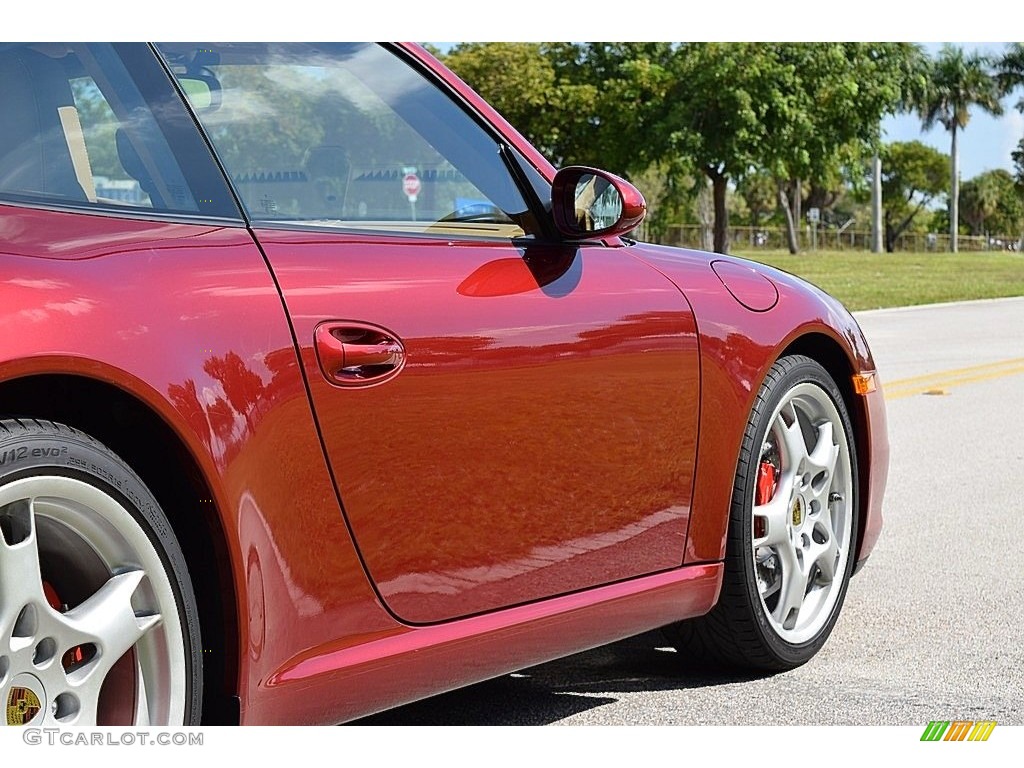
(631, 245, 889, 563)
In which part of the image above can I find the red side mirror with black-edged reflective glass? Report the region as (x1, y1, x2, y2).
(551, 166, 647, 238)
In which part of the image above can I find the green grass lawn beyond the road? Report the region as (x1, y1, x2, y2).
(734, 249, 1024, 310)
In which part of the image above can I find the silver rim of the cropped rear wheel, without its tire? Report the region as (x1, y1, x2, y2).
(0, 474, 188, 726)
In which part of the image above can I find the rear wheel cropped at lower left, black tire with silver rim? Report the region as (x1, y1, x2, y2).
(0, 419, 203, 725)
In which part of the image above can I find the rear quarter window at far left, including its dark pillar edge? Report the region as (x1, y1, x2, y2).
(0, 43, 238, 217)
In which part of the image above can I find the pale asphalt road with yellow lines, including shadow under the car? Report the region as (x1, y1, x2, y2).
(360, 298, 1024, 727)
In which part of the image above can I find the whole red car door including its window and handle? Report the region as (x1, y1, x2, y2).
(161, 44, 699, 623)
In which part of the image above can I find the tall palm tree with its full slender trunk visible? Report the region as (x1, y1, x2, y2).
(918, 43, 1002, 253)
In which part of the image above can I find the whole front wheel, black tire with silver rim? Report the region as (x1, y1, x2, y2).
(666, 355, 858, 672)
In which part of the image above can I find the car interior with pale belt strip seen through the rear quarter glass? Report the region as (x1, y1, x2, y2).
(0, 43, 205, 211)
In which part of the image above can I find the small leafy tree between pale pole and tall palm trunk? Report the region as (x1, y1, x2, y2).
(881, 141, 949, 253)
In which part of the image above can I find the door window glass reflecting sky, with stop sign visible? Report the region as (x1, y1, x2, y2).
(157, 43, 538, 238)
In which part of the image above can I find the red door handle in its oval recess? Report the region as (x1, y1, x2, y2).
(313, 323, 406, 387)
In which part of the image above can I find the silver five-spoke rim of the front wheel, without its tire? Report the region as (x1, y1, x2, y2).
(751, 382, 854, 644)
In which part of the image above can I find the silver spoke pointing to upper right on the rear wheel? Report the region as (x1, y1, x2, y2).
(61, 570, 161, 696)
